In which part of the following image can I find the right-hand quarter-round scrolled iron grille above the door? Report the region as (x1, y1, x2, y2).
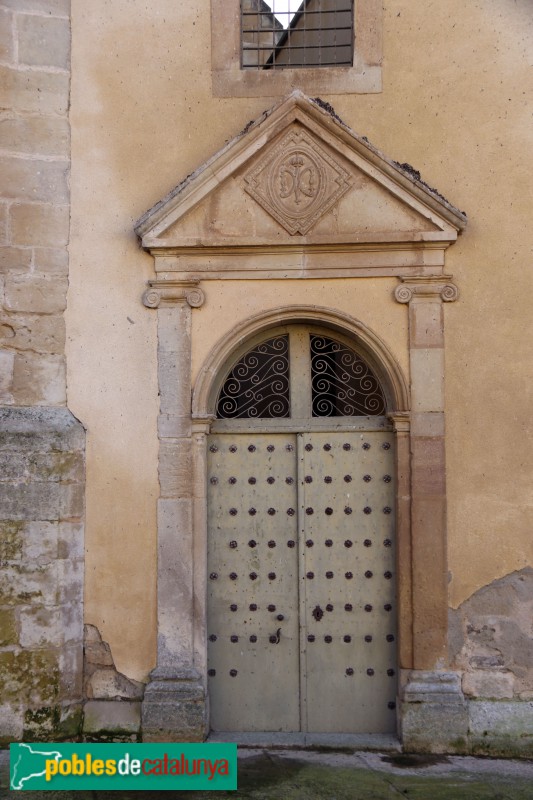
(311, 335, 386, 417)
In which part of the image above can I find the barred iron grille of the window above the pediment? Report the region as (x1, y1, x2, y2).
(241, 0, 354, 69)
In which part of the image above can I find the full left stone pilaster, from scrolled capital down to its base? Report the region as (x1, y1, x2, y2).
(142, 280, 206, 741)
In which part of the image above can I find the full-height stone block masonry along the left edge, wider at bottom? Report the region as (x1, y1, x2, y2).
(0, 0, 85, 741)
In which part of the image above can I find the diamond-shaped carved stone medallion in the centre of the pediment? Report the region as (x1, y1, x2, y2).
(244, 128, 352, 234)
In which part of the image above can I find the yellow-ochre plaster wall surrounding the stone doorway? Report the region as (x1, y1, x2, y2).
(67, 0, 533, 678)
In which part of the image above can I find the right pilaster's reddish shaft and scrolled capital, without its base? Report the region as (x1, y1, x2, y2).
(395, 276, 458, 670)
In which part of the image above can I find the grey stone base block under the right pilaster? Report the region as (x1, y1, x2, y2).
(400, 670, 469, 753)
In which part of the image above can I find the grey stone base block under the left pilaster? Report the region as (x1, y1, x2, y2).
(141, 668, 207, 742)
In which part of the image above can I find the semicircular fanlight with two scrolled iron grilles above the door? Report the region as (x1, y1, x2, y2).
(216, 333, 386, 419)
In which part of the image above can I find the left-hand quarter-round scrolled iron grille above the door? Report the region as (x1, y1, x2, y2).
(217, 336, 290, 419)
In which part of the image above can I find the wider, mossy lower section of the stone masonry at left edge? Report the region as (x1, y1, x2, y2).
(0, 407, 85, 742)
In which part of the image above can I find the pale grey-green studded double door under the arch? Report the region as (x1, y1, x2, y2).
(207, 428, 397, 733)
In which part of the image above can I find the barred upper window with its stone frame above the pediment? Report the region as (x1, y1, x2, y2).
(211, 0, 383, 97)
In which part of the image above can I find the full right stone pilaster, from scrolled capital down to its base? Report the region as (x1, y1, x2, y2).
(395, 275, 468, 753)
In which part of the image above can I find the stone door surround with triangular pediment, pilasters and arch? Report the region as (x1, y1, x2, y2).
(135, 91, 466, 747)
